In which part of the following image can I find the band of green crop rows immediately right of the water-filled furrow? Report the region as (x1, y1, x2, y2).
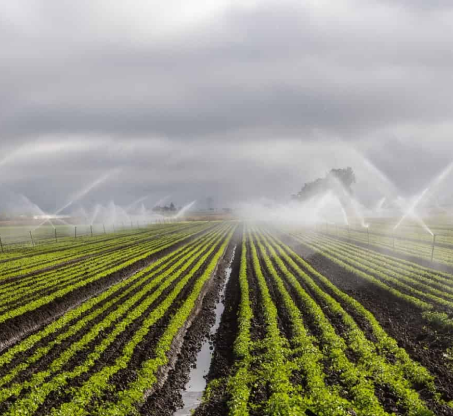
(201, 226, 447, 416)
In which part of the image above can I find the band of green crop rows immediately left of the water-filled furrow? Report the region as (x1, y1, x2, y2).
(0, 224, 234, 415)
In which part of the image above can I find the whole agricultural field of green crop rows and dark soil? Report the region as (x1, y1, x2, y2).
(0, 221, 453, 416)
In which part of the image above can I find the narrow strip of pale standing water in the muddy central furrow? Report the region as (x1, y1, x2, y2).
(173, 247, 236, 416)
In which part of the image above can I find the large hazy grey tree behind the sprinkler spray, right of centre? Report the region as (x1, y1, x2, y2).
(291, 167, 356, 201)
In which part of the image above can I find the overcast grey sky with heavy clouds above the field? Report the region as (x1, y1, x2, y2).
(0, 0, 453, 210)
